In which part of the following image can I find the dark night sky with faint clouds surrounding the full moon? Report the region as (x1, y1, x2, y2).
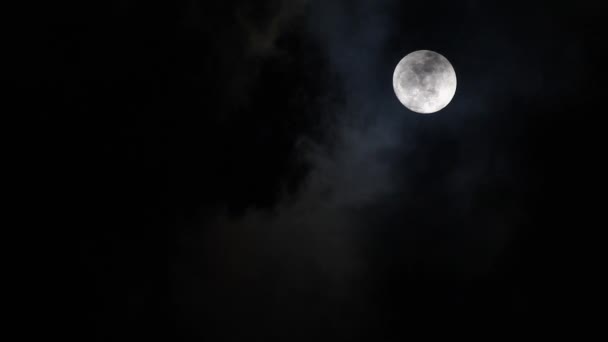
(21, 0, 608, 342)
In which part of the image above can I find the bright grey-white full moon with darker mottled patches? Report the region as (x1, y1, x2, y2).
(393, 50, 456, 114)
